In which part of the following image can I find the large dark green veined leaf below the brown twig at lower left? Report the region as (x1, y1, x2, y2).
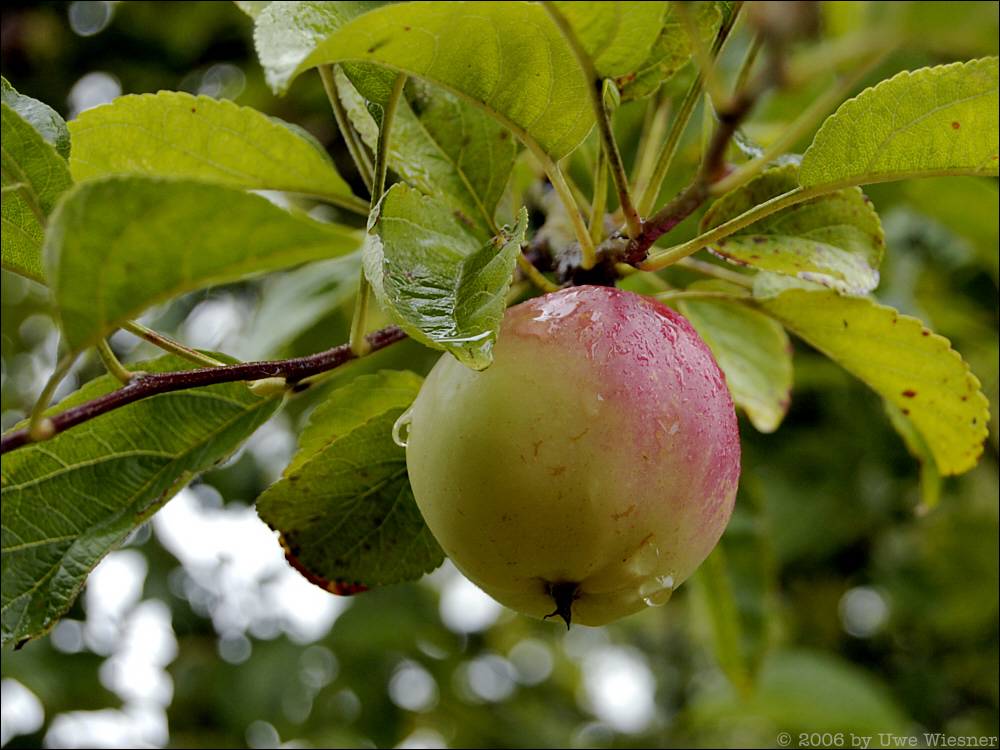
(0, 356, 280, 644)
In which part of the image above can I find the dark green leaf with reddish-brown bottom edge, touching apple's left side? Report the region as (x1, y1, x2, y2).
(257, 371, 444, 594)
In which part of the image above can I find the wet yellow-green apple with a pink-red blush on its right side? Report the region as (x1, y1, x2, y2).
(406, 286, 740, 625)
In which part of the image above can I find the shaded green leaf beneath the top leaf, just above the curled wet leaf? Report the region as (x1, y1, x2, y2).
(337, 71, 517, 237)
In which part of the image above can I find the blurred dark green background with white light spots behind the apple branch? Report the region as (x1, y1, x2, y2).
(0, 2, 1000, 748)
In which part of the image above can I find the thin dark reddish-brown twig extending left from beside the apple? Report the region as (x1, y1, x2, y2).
(0, 326, 406, 453)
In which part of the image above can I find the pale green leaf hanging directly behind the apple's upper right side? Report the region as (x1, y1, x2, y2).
(677, 283, 792, 432)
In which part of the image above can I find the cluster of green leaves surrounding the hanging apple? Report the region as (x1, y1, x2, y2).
(0, 0, 998, 656)
